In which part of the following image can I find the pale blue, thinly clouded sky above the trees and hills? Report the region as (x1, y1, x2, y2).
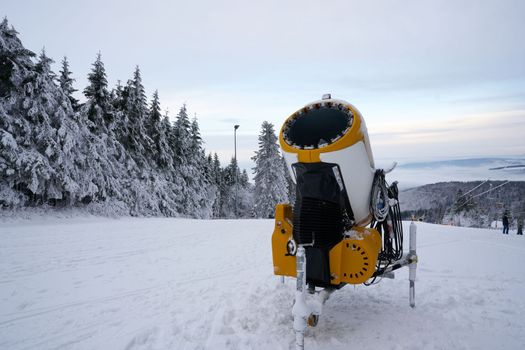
(0, 0, 525, 174)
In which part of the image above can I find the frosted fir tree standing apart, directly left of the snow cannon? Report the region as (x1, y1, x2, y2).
(252, 121, 288, 218)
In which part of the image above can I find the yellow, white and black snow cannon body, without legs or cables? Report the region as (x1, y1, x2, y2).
(272, 95, 381, 287)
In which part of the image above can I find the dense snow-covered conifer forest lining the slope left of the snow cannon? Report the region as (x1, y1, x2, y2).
(0, 19, 288, 218)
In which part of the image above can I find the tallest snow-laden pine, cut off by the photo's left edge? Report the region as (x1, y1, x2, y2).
(0, 18, 39, 207)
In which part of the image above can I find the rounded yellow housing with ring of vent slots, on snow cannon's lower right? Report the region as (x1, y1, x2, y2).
(330, 227, 381, 285)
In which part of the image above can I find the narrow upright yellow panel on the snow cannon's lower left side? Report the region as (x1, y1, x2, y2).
(272, 204, 297, 277)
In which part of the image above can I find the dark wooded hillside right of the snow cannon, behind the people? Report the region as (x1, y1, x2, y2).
(399, 181, 525, 227)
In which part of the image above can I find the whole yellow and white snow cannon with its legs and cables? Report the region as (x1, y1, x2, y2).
(272, 94, 417, 348)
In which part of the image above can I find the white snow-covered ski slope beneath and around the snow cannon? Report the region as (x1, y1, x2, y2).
(0, 218, 525, 350)
